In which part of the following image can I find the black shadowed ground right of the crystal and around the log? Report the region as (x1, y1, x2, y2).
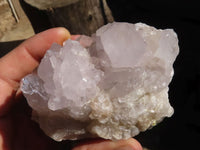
(0, 0, 200, 150)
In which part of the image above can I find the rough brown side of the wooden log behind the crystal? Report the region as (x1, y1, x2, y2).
(47, 0, 113, 35)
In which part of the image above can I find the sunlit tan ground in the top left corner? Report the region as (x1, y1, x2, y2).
(0, 0, 34, 42)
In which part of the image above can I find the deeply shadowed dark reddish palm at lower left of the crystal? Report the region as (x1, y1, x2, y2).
(0, 94, 65, 150)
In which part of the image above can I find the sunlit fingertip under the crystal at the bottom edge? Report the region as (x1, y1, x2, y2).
(73, 138, 142, 150)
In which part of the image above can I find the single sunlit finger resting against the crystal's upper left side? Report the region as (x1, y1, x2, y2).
(0, 28, 70, 82)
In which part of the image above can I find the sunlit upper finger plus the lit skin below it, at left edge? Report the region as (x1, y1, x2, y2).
(0, 28, 70, 116)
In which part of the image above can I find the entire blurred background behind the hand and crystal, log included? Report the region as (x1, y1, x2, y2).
(0, 0, 200, 150)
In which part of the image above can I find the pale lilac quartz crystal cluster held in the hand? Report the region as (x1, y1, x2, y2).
(21, 22, 179, 141)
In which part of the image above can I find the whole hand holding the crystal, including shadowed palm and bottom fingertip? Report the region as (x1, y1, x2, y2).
(0, 28, 142, 150)
